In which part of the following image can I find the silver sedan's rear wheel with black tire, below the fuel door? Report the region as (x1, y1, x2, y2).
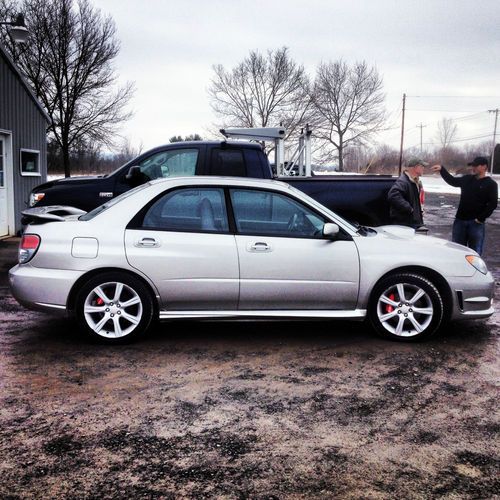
(75, 272, 154, 344)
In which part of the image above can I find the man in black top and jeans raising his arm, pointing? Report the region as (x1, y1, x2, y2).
(432, 156, 498, 255)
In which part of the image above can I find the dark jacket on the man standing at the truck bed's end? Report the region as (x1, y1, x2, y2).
(388, 172, 424, 227)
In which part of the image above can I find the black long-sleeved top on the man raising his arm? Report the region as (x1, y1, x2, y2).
(441, 166, 498, 222)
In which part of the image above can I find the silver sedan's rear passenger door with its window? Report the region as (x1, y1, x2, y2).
(125, 186, 239, 310)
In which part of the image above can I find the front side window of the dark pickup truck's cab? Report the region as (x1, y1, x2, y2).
(139, 148, 198, 180)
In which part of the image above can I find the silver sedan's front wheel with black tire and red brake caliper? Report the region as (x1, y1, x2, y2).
(368, 273, 444, 341)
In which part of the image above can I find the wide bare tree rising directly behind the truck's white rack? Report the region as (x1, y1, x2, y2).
(208, 47, 310, 151)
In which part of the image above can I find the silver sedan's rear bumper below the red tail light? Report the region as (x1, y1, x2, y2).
(9, 264, 83, 313)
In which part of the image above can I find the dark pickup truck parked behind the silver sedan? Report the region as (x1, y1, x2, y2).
(29, 141, 395, 226)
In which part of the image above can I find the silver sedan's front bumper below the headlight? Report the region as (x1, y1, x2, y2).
(448, 271, 495, 320)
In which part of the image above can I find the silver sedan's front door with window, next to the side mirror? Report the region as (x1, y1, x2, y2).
(230, 188, 359, 310)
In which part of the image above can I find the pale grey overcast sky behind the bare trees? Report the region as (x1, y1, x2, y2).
(93, 0, 500, 156)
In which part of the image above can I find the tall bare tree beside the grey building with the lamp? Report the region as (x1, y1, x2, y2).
(3, 0, 134, 177)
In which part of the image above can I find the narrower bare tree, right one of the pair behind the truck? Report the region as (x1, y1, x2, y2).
(312, 60, 385, 171)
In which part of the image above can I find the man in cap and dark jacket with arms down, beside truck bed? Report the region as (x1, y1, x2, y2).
(388, 158, 429, 229)
